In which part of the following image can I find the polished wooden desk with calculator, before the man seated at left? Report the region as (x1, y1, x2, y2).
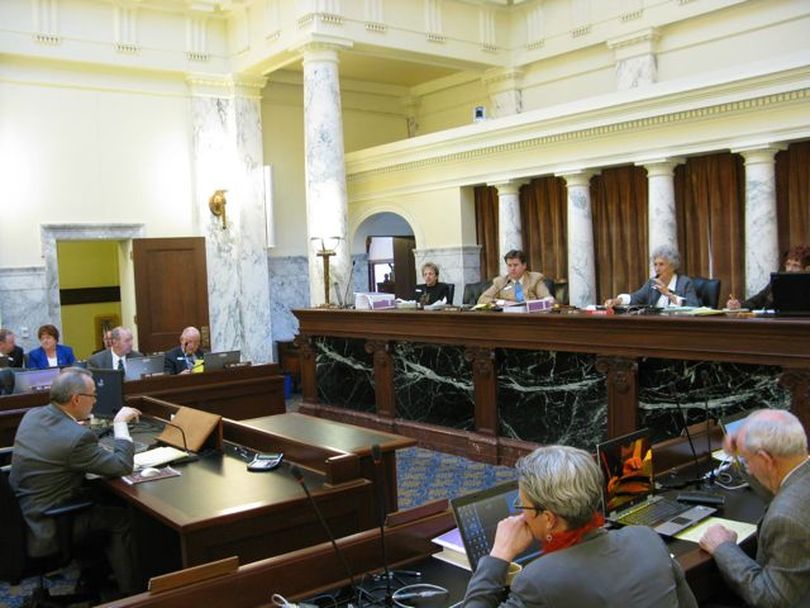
(103, 397, 377, 576)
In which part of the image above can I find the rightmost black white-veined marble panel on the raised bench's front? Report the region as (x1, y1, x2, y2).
(638, 359, 790, 441)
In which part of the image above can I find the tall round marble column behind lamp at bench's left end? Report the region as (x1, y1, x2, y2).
(300, 42, 351, 305)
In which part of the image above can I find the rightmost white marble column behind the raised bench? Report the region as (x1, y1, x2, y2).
(734, 146, 783, 298)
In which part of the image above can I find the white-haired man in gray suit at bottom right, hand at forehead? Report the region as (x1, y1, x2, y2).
(700, 410, 810, 608)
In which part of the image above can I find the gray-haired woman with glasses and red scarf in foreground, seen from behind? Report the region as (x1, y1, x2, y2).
(464, 446, 697, 608)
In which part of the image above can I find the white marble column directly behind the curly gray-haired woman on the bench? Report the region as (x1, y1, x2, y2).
(639, 158, 683, 270)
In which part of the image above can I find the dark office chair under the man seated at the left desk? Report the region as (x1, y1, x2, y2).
(0, 449, 97, 608)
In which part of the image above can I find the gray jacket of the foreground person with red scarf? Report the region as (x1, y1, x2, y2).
(464, 526, 697, 608)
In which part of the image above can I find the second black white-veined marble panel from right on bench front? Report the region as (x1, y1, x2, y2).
(497, 350, 607, 451)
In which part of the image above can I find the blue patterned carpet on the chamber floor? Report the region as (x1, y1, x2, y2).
(0, 448, 515, 608)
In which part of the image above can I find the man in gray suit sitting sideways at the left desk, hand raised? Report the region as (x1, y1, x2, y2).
(9, 367, 142, 595)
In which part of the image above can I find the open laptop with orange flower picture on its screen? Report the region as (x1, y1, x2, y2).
(596, 429, 716, 536)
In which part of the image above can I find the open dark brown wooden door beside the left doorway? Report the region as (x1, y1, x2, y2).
(132, 237, 211, 353)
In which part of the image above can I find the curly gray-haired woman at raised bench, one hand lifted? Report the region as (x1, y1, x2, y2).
(605, 246, 700, 308)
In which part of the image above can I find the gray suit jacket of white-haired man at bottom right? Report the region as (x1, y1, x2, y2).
(714, 461, 810, 608)
